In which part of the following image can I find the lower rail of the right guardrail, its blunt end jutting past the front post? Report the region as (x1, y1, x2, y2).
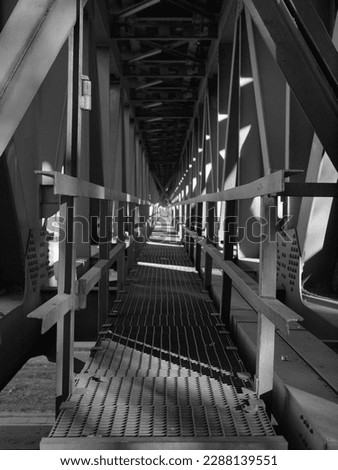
(198, 240, 303, 334)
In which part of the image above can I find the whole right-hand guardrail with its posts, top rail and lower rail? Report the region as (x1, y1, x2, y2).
(176, 170, 338, 396)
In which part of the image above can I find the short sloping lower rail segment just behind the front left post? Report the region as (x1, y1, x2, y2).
(77, 243, 125, 309)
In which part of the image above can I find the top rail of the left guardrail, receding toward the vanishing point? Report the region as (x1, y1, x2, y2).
(35, 170, 150, 205)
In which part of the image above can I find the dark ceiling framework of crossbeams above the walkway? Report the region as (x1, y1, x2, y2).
(107, 0, 223, 193)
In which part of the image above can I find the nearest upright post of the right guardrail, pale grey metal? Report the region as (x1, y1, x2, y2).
(255, 196, 277, 402)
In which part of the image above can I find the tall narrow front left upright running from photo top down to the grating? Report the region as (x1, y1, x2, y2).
(55, 0, 83, 415)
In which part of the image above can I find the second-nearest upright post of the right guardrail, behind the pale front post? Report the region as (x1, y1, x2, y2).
(220, 201, 237, 327)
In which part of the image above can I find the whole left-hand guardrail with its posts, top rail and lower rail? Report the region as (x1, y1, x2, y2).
(28, 171, 150, 410)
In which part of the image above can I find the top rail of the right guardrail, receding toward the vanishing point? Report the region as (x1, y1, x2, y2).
(176, 170, 302, 206)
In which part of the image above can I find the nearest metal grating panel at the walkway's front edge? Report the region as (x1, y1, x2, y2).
(50, 405, 275, 445)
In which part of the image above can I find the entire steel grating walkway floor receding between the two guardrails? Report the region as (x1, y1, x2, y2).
(41, 223, 286, 449)
